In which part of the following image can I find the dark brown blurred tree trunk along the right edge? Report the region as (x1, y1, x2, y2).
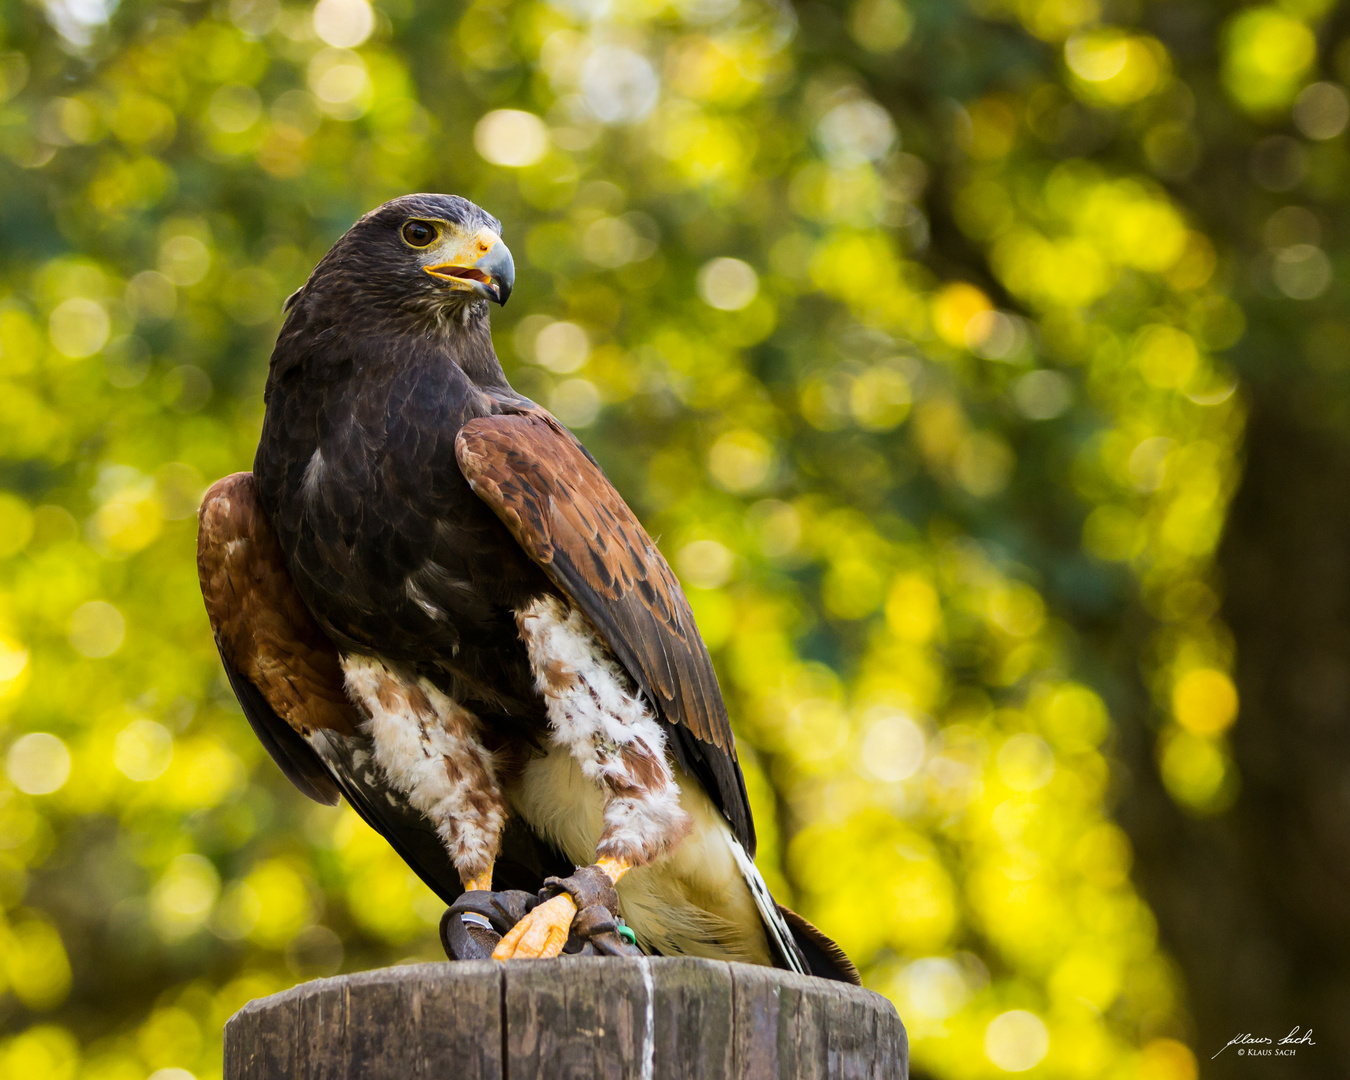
(1125, 399, 1350, 1080)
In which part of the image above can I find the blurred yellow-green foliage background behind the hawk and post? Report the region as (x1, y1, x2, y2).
(0, 0, 1350, 1080)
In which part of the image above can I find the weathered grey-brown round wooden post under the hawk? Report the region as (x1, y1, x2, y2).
(225, 957, 909, 1080)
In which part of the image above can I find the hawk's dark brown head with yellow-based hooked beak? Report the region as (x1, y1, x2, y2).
(295, 194, 516, 323)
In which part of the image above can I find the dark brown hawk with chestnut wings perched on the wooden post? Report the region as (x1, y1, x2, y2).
(197, 194, 857, 981)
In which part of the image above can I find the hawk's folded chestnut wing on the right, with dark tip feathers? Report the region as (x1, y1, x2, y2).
(455, 409, 755, 856)
